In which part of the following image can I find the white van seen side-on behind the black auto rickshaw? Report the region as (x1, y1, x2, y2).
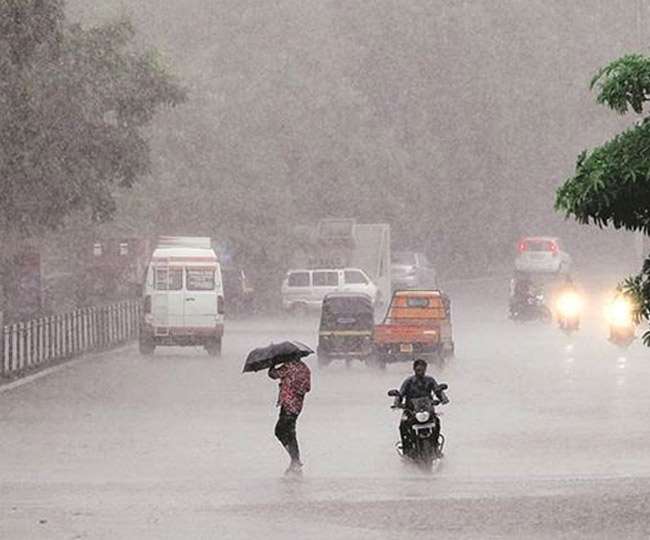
(282, 268, 379, 313)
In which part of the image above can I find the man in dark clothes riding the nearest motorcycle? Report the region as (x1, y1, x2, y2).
(393, 358, 449, 455)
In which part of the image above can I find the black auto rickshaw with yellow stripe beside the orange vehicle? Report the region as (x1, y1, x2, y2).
(318, 293, 375, 367)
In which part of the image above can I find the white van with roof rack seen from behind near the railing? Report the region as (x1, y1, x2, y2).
(140, 237, 224, 356)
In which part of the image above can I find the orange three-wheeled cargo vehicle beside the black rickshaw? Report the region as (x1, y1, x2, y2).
(374, 290, 454, 368)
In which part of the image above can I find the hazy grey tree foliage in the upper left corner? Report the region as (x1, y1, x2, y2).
(0, 0, 185, 236)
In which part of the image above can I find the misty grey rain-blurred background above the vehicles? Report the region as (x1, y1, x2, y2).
(67, 0, 647, 286)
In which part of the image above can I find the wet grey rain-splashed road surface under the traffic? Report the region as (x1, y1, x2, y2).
(0, 284, 650, 539)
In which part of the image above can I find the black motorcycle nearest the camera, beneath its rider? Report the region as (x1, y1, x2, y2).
(388, 384, 449, 471)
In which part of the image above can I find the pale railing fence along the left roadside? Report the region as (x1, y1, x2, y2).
(0, 300, 141, 378)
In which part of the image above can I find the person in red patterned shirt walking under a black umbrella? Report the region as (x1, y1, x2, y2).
(244, 341, 313, 474)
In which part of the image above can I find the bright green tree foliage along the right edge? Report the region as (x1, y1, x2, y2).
(556, 54, 650, 345)
